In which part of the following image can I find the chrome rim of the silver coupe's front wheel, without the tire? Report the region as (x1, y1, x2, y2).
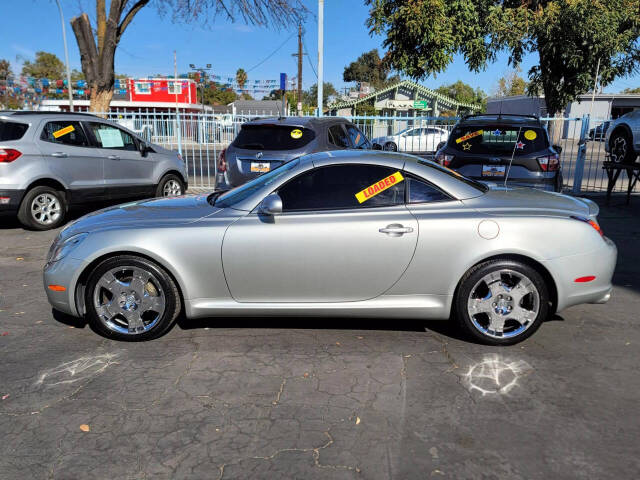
(93, 266, 166, 335)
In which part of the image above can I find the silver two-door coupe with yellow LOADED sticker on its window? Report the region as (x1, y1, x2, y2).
(44, 151, 617, 345)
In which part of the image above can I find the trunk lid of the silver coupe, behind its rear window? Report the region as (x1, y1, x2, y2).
(464, 187, 600, 218)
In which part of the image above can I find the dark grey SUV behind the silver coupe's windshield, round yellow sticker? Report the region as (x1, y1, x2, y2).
(218, 117, 372, 189)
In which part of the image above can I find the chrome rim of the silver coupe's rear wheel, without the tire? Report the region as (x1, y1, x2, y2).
(467, 269, 540, 338)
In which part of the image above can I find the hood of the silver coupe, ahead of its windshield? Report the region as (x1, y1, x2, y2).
(60, 195, 221, 239)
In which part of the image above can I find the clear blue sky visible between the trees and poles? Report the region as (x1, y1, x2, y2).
(0, 0, 640, 94)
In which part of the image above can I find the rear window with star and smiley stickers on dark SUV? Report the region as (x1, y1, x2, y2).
(449, 124, 549, 156)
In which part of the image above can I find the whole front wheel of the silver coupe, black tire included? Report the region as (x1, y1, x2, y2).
(85, 255, 182, 342)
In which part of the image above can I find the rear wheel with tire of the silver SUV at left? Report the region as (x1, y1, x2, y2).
(18, 186, 67, 230)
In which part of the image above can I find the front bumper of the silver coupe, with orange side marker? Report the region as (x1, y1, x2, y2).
(43, 256, 88, 317)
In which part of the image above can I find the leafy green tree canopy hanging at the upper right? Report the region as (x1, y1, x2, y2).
(366, 0, 640, 115)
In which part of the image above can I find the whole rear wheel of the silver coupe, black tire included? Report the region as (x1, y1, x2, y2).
(454, 259, 549, 345)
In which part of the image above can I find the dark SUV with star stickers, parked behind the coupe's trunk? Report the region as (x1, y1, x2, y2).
(436, 114, 562, 192)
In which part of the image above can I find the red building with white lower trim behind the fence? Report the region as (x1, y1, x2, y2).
(39, 78, 200, 113)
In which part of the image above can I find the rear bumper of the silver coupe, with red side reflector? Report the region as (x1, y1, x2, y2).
(544, 237, 618, 311)
